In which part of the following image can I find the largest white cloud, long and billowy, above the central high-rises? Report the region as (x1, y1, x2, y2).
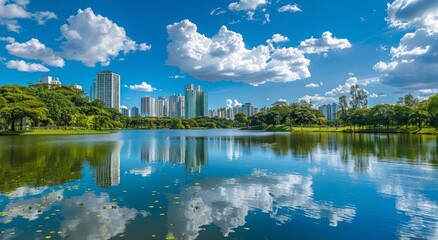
(167, 20, 310, 86)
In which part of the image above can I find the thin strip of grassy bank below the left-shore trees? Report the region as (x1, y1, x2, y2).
(0, 129, 110, 136)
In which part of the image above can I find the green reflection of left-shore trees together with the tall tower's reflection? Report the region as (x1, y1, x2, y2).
(0, 138, 120, 192)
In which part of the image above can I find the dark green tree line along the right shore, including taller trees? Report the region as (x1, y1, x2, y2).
(234, 85, 438, 129)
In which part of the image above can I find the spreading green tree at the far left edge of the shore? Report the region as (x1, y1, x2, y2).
(0, 85, 48, 131)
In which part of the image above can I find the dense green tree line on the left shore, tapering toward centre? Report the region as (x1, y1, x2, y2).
(0, 84, 233, 131)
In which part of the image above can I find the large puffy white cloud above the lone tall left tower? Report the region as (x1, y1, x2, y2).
(61, 8, 150, 67)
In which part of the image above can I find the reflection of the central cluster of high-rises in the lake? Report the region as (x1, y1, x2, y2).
(141, 137, 208, 172)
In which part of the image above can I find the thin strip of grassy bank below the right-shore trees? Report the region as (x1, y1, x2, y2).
(251, 125, 438, 135)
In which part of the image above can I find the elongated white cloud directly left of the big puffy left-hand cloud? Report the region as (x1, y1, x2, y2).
(6, 38, 64, 67)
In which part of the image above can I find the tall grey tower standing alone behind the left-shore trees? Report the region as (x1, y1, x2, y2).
(96, 71, 120, 109)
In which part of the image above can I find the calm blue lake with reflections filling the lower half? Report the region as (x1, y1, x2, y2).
(0, 130, 438, 239)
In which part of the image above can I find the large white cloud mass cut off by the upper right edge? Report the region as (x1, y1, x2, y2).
(374, 0, 438, 90)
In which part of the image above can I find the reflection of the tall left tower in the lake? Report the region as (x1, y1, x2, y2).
(94, 142, 121, 188)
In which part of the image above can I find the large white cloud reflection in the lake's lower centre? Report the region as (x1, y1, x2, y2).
(168, 171, 356, 239)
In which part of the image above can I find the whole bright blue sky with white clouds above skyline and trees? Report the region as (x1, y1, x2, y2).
(0, 0, 438, 109)
